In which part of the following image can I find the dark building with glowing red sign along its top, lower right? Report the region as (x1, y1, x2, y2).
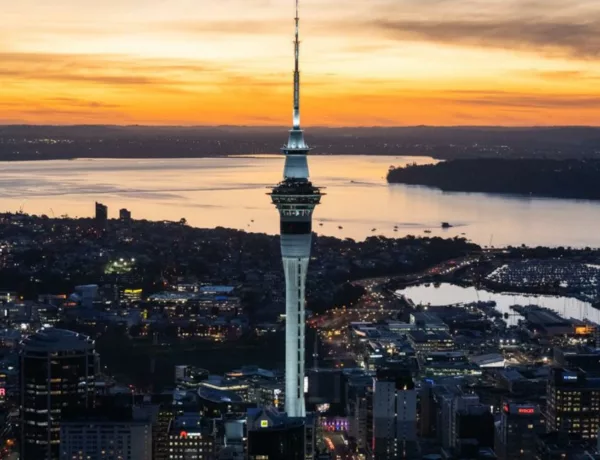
(494, 402, 543, 460)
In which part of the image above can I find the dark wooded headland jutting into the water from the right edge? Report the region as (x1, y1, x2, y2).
(387, 159, 600, 200)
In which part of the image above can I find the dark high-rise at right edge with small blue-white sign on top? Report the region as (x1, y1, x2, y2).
(546, 368, 600, 440)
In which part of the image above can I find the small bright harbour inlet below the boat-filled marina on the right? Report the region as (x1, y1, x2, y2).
(398, 283, 600, 325)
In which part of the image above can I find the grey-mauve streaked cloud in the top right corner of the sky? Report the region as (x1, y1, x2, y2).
(358, 0, 600, 59)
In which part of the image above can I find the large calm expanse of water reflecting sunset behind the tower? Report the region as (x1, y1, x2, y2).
(0, 156, 600, 247)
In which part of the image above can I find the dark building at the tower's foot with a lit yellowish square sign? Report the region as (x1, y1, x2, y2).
(247, 407, 306, 460)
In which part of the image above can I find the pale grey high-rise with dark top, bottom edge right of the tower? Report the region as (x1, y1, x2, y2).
(373, 369, 417, 459)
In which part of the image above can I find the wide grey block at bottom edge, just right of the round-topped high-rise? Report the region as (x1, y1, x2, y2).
(60, 410, 152, 460)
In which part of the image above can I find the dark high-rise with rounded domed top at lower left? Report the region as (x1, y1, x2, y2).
(20, 328, 96, 460)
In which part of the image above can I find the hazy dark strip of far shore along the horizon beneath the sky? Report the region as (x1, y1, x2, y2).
(0, 125, 600, 161)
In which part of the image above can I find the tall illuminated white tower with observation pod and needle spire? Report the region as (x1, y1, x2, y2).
(270, 0, 323, 417)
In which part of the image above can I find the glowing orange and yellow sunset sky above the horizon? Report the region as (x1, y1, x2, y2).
(0, 0, 600, 126)
